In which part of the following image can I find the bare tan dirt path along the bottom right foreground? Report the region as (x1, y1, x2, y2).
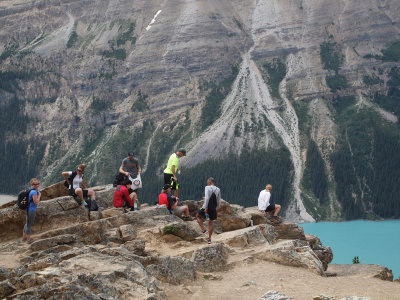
(165, 260, 400, 300)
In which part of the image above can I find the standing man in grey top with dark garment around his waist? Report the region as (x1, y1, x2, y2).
(196, 177, 221, 244)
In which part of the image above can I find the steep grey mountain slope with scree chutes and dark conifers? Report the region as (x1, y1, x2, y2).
(0, 0, 400, 221)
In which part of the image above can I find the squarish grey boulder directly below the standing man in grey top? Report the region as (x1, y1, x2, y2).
(191, 243, 229, 273)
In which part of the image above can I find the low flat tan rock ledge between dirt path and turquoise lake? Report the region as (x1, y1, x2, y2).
(328, 264, 393, 281)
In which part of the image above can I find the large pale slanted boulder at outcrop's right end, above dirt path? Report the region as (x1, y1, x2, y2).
(255, 240, 324, 275)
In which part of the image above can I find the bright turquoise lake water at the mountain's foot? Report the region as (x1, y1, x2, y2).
(299, 220, 400, 279)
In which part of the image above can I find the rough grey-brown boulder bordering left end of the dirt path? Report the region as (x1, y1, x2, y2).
(146, 256, 195, 284)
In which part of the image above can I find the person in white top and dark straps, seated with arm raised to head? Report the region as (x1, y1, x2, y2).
(61, 164, 96, 206)
